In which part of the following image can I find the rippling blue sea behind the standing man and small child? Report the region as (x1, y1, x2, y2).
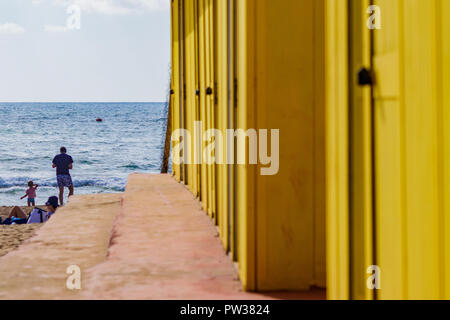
(0, 103, 167, 206)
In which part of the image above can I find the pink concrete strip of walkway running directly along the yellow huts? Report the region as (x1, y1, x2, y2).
(82, 174, 324, 300)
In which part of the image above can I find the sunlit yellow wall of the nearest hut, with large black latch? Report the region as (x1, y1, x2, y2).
(326, 0, 450, 299)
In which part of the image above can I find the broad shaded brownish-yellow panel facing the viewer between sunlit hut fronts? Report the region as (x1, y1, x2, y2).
(255, 0, 325, 290)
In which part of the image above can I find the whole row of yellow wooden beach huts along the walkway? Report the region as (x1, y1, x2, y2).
(170, 0, 450, 299)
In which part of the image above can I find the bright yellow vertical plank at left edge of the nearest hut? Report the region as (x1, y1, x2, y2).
(325, 0, 350, 299)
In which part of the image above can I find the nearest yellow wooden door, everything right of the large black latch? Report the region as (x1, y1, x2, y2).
(372, 0, 449, 299)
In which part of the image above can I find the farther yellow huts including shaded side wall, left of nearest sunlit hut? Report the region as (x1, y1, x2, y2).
(173, 0, 325, 291)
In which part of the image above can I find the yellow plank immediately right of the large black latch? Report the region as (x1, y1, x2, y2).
(372, 0, 407, 299)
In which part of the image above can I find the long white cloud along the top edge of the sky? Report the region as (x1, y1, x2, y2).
(32, 0, 170, 15)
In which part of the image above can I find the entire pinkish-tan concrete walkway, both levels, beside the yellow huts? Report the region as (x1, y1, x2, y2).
(0, 174, 324, 300)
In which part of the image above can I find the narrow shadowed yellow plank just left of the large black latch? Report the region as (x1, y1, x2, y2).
(349, 0, 374, 300)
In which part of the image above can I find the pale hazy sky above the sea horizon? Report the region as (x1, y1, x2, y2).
(0, 0, 170, 102)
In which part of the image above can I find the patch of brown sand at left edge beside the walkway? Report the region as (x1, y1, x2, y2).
(0, 206, 45, 257)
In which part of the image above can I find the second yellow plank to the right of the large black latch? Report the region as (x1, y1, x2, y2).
(402, 0, 441, 299)
